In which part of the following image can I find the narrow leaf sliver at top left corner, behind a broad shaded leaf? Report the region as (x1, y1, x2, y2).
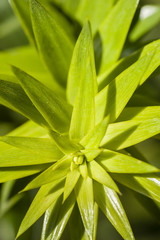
(10, 0, 35, 44)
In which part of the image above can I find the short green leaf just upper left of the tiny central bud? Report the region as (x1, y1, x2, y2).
(49, 131, 83, 154)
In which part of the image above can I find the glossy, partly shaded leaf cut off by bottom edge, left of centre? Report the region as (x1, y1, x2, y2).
(41, 194, 76, 240)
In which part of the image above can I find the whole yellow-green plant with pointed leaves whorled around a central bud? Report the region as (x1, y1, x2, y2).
(0, 0, 160, 240)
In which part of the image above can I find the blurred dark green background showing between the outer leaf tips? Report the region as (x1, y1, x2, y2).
(0, 0, 160, 240)
